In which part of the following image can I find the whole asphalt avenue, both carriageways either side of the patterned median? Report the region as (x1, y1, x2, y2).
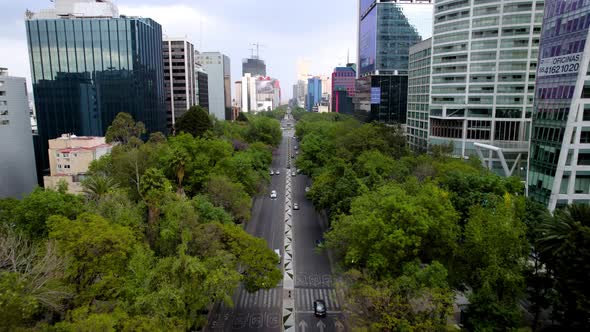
(206, 113, 347, 332)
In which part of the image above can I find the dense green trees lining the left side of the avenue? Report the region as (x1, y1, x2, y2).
(0, 110, 281, 331)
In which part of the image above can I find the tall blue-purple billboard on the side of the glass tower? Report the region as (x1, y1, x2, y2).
(359, 7, 377, 76)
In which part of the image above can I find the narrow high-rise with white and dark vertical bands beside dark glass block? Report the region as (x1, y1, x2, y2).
(162, 38, 197, 129)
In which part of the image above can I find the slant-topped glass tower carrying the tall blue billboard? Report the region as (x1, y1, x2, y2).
(354, 0, 422, 124)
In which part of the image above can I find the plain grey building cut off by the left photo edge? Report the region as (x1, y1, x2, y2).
(0, 68, 37, 198)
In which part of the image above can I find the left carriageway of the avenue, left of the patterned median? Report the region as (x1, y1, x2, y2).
(206, 120, 290, 331)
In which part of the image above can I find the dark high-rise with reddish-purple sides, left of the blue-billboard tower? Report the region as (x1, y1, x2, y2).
(331, 64, 356, 114)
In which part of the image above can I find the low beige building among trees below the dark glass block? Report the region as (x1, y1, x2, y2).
(43, 134, 113, 194)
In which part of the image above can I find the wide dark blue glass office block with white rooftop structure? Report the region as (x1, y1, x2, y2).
(26, 0, 166, 178)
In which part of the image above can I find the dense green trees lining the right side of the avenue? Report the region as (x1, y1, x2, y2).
(296, 113, 590, 331)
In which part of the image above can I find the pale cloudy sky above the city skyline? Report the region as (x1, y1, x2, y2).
(0, 0, 432, 100)
